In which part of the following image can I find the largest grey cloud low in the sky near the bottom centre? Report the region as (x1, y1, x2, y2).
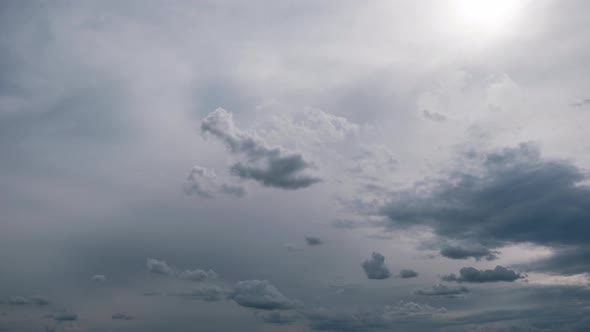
(229, 280, 297, 310)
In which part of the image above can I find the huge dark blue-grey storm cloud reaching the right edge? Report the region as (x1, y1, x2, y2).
(382, 144, 590, 272)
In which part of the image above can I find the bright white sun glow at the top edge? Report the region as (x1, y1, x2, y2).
(453, 0, 524, 33)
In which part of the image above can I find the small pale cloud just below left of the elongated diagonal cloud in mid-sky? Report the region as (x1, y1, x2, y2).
(183, 165, 246, 198)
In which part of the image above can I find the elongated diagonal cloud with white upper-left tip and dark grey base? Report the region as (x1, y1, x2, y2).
(201, 108, 320, 190)
